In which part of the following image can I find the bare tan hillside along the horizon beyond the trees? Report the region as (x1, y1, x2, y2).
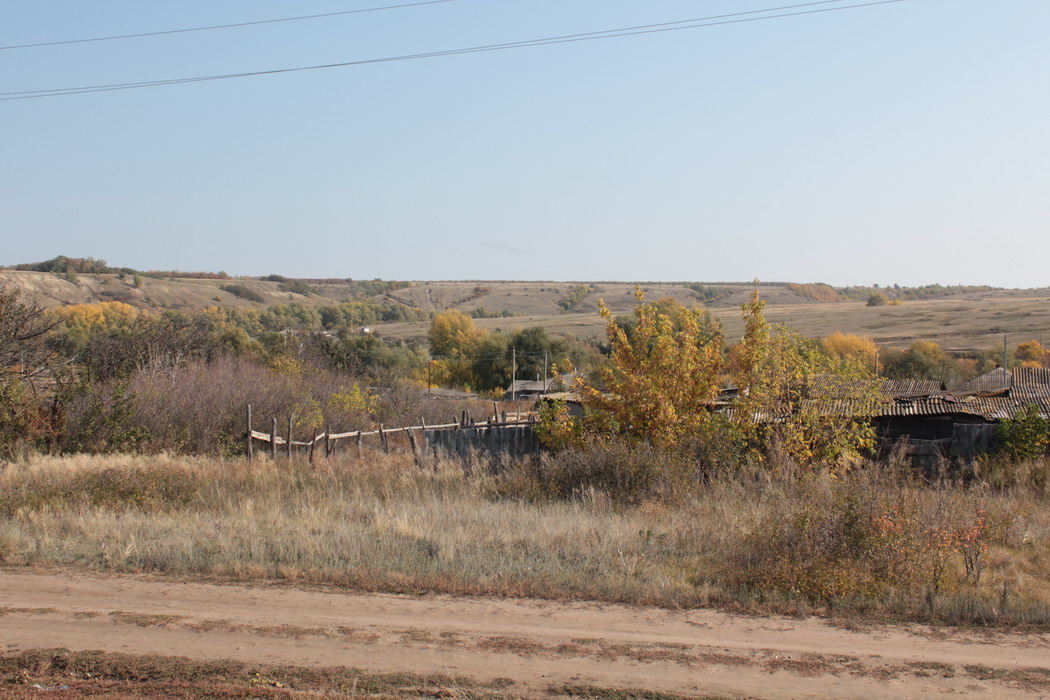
(0, 257, 1050, 349)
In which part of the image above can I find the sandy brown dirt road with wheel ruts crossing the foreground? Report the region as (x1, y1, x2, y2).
(0, 570, 1050, 698)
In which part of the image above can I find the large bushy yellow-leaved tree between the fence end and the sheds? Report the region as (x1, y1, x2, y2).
(579, 289, 722, 446)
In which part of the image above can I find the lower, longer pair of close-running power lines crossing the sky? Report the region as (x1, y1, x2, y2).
(0, 0, 908, 102)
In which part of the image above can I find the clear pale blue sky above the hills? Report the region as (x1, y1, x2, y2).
(0, 0, 1050, 287)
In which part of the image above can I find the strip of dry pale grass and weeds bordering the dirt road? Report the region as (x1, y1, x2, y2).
(0, 454, 1050, 629)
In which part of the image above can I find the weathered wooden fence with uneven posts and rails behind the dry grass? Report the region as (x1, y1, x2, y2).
(245, 404, 540, 463)
